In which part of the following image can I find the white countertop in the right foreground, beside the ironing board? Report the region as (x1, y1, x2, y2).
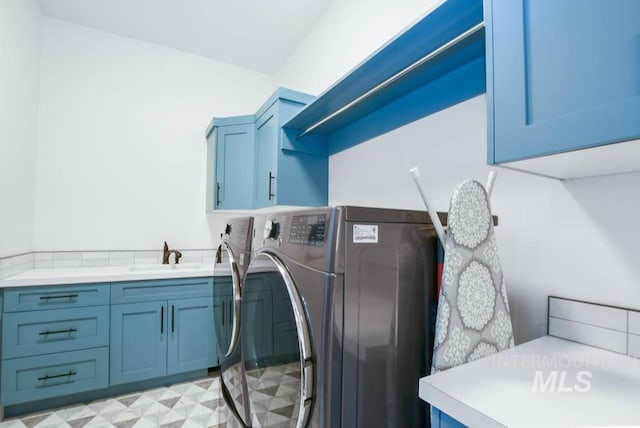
(419, 336, 640, 427)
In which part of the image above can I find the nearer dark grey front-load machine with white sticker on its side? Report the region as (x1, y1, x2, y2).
(240, 206, 436, 428)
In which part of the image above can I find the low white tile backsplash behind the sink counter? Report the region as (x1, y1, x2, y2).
(0, 250, 216, 279)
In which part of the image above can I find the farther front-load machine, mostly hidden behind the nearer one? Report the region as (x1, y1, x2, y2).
(214, 217, 253, 426)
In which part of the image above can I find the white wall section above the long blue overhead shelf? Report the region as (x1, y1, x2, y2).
(276, 0, 440, 95)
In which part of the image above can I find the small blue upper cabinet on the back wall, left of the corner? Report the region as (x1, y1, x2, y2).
(207, 116, 255, 209)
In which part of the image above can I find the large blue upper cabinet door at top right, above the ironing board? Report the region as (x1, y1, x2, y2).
(485, 0, 640, 164)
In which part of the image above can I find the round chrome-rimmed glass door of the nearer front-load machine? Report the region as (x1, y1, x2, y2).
(241, 253, 314, 428)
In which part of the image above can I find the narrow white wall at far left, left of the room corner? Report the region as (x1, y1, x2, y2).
(0, 0, 41, 257)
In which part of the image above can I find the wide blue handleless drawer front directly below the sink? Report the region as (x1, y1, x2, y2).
(111, 277, 213, 304)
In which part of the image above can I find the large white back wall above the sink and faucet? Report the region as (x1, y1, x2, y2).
(35, 18, 274, 251)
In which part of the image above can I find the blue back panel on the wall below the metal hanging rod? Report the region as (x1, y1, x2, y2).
(328, 53, 486, 154)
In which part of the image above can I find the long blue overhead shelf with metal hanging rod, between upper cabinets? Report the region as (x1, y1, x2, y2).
(284, 0, 486, 154)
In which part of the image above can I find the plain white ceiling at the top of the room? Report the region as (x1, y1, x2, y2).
(39, 0, 332, 74)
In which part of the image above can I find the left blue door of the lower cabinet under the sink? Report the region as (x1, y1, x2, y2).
(110, 301, 168, 385)
